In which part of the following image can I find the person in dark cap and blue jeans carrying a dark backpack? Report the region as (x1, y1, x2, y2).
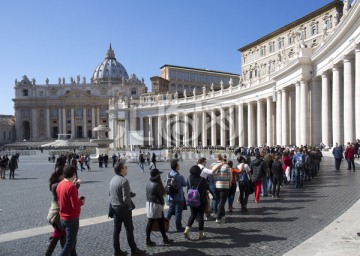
(165, 159, 186, 232)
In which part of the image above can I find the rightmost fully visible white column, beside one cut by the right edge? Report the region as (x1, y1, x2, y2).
(343, 56, 355, 143)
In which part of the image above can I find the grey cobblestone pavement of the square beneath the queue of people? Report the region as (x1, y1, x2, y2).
(0, 152, 360, 256)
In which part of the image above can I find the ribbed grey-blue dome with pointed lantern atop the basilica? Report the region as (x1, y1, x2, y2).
(92, 44, 129, 83)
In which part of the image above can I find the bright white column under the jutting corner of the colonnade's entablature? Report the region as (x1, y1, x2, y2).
(300, 80, 309, 145)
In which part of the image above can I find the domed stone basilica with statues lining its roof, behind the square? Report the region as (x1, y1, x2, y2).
(13, 45, 147, 141)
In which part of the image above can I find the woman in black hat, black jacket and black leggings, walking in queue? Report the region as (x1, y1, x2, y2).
(146, 169, 174, 246)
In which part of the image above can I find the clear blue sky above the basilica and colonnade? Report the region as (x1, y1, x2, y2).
(0, 0, 331, 115)
